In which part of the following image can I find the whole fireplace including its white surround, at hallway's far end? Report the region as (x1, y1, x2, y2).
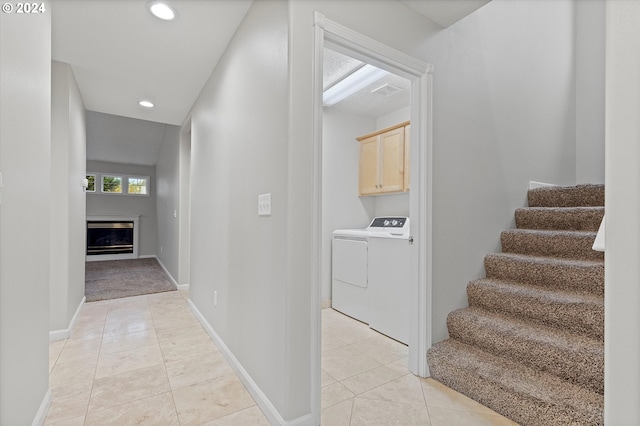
(86, 216, 138, 260)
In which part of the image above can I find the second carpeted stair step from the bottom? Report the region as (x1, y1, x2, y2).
(447, 311, 604, 394)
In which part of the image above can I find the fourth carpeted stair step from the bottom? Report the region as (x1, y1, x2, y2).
(484, 255, 604, 295)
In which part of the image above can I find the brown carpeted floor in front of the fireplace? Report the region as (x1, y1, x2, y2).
(85, 258, 176, 302)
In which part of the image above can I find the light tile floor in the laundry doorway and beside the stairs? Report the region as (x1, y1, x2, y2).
(321, 309, 516, 426)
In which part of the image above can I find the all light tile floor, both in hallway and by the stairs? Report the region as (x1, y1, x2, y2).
(45, 291, 514, 426)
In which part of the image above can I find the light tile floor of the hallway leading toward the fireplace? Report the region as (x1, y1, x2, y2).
(45, 291, 269, 426)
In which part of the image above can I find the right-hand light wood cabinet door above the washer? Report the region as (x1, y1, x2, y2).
(379, 127, 404, 192)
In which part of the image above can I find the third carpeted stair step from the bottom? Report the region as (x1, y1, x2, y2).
(467, 282, 604, 341)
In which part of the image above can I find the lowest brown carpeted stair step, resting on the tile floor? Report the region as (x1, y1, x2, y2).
(428, 339, 604, 425)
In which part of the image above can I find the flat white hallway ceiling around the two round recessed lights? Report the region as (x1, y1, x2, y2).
(51, 0, 252, 125)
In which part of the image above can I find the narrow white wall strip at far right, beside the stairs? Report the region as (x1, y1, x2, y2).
(604, 1, 640, 425)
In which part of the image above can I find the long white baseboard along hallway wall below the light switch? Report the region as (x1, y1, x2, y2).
(187, 299, 311, 426)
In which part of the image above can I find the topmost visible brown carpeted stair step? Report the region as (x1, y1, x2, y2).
(527, 185, 604, 207)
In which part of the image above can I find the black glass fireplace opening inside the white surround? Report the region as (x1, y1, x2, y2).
(87, 221, 133, 255)
